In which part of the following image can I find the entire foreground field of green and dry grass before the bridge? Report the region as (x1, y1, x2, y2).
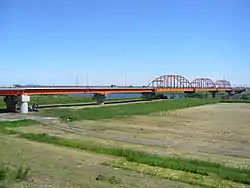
(0, 99, 250, 188)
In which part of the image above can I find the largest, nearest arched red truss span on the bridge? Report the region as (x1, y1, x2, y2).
(148, 75, 190, 88)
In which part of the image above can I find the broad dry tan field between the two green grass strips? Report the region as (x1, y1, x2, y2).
(9, 104, 250, 167)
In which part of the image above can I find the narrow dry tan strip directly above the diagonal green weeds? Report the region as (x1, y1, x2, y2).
(15, 123, 250, 168)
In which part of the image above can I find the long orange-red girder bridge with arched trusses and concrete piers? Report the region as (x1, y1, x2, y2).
(0, 75, 246, 113)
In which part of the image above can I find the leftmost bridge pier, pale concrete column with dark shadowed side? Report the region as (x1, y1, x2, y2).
(4, 95, 30, 113)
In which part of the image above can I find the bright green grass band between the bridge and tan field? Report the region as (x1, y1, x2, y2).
(38, 99, 218, 121)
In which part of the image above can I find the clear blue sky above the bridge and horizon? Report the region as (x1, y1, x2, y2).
(0, 0, 250, 85)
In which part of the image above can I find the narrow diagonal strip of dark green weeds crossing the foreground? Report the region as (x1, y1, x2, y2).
(20, 133, 250, 185)
